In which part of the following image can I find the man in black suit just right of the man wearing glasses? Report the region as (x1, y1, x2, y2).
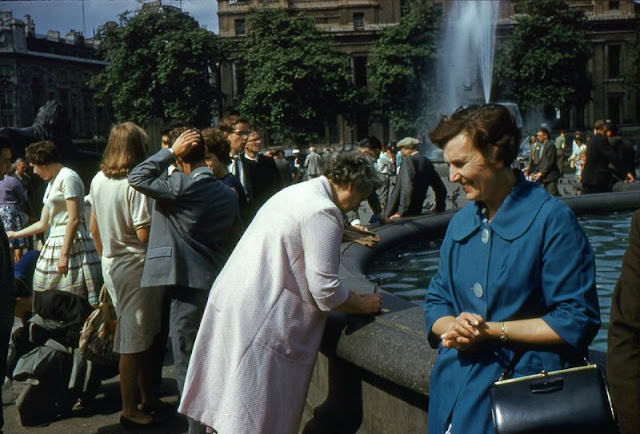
(241, 131, 282, 220)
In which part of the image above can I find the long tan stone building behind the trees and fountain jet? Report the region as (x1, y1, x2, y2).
(217, 0, 640, 143)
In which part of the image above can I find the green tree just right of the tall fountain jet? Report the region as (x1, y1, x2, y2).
(494, 0, 592, 108)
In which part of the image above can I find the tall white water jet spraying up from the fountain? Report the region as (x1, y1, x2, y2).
(436, 0, 500, 113)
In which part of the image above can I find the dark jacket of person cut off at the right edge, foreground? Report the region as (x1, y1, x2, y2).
(607, 211, 640, 434)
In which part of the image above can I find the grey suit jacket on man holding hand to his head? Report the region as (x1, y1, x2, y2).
(129, 149, 238, 291)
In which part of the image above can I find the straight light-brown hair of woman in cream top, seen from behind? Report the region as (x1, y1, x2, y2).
(100, 122, 149, 179)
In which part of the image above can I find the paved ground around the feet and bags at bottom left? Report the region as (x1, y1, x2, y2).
(2, 366, 187, 434)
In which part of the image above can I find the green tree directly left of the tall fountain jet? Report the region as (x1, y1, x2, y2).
(368, 0, 439, 133)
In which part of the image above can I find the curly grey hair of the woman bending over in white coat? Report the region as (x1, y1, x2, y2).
(324, 151, 382, 194)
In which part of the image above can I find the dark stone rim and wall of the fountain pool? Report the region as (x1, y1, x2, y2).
(302, 192, 640, 433)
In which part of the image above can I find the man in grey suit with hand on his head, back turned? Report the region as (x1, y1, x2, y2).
(129, 130, 238, 433)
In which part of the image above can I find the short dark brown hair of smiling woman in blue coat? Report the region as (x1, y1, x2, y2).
(429, 104, 519, 166)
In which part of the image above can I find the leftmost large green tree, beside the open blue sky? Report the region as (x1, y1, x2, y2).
(92, 8, 222, 125)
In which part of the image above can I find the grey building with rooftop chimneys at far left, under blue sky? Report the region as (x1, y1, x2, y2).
(0, 10, 110, 138)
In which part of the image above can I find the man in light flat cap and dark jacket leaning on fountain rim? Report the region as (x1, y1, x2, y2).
(385, 137, 447, 220)
